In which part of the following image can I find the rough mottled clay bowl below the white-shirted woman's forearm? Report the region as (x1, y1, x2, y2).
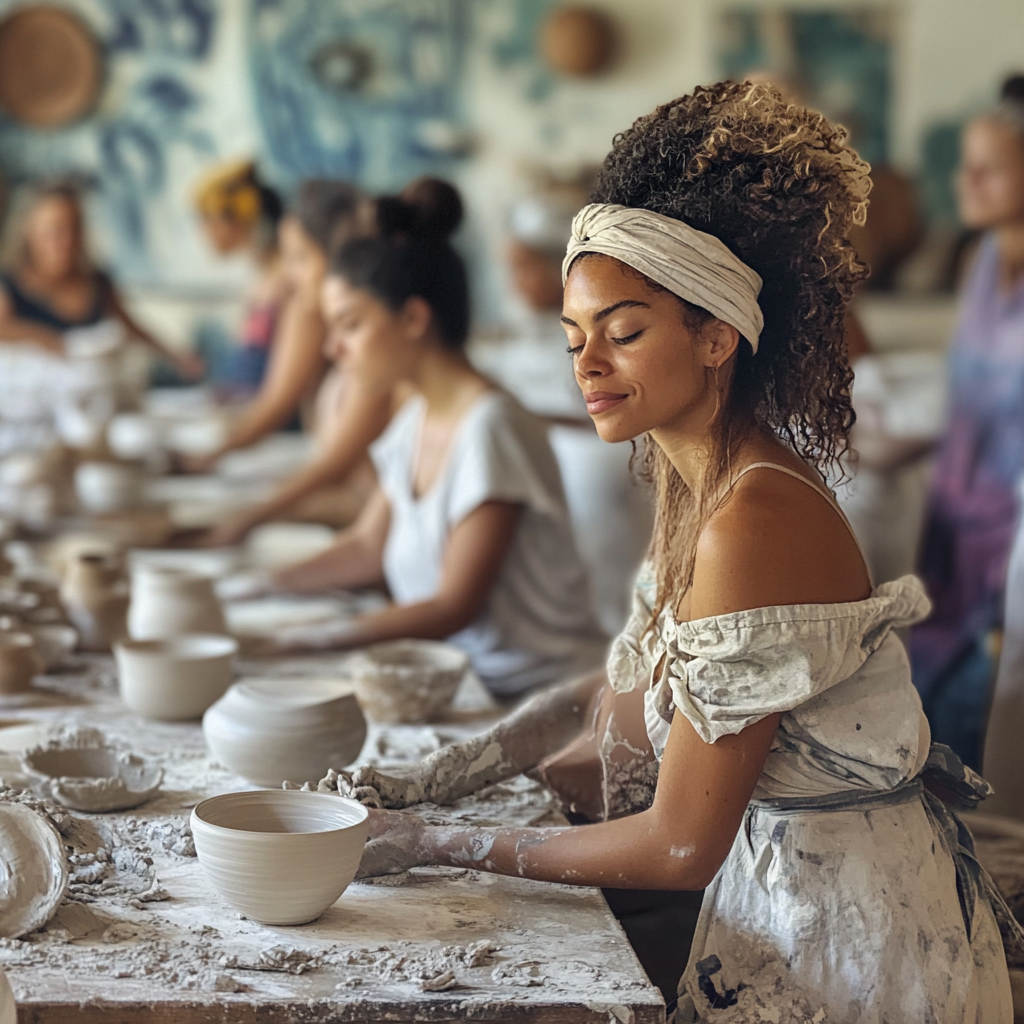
(345, 640, 469, 724)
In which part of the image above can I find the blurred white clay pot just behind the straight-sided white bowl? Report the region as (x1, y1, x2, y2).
(128, 564, 227, 640)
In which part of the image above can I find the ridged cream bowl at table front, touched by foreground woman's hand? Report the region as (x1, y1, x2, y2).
(191, 790, 369, 925)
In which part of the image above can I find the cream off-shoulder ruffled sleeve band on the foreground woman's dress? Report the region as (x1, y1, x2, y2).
(608, 577, 930, 743)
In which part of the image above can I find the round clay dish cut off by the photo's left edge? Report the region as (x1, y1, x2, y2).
(0, 802, 68, 939)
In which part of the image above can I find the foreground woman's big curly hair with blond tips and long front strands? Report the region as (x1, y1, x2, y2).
(591, 82, 870, 611)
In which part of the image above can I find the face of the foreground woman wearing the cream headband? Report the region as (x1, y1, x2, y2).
(562, 256, 714, 441)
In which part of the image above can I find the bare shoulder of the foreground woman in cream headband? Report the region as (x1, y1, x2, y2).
(690, 470, 870, 618)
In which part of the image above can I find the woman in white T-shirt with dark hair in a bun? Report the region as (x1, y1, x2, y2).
(256, 182, 606, 696)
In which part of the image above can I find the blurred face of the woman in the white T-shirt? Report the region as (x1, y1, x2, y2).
(322, 275, 419, 386)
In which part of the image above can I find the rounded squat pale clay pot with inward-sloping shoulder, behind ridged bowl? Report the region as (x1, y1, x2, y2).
(203, 679, 367, 787)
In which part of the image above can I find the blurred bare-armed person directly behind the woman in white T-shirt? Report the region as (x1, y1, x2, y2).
(191, 180, 407, 547)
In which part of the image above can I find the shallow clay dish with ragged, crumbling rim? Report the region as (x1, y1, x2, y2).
(22, 729, 164, 812)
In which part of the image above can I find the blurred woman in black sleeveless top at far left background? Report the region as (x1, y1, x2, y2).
(0, 183, 197, 379)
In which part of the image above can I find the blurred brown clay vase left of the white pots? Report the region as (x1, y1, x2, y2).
(60, 554, 128, 651)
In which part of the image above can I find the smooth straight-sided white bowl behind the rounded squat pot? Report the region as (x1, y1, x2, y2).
(115, 633, 239, 722)
